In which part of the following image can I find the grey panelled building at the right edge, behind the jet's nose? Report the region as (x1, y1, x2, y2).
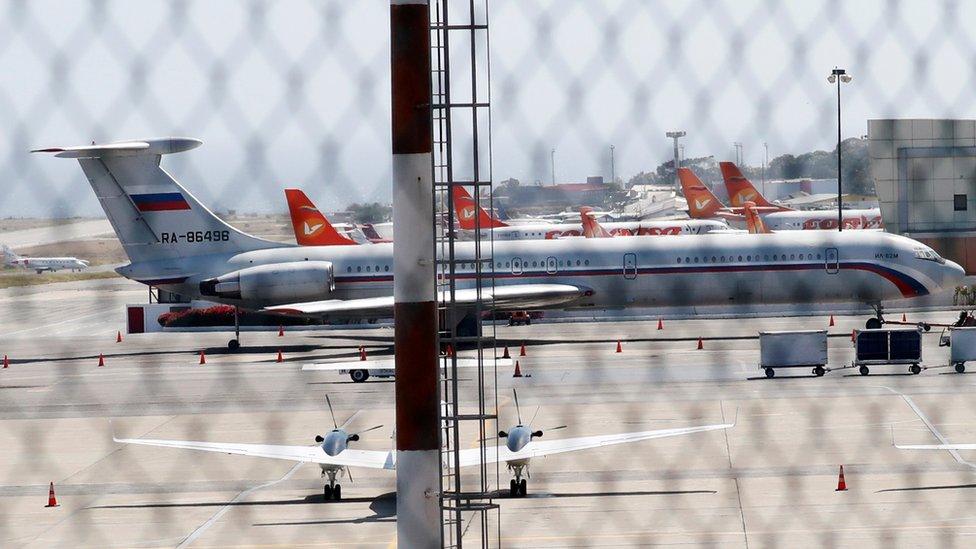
(868, 119, 976, 274)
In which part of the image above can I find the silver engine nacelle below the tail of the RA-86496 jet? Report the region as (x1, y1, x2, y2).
(200, 261, 335, 303)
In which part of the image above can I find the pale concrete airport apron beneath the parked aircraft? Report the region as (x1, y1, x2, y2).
(0, 280, 976, 547)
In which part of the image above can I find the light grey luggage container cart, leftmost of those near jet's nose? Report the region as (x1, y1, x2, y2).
(759, 330, 827, 377)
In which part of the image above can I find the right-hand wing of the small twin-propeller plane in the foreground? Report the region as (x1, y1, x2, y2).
(461, 423, 735, 467)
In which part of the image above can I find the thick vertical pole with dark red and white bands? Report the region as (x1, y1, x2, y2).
(390, 0, 441, 548)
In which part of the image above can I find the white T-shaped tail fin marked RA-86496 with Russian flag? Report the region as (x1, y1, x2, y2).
(31, 137, 281, 263)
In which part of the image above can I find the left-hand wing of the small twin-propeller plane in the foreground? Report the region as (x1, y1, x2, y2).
(112, 436, 395, 469)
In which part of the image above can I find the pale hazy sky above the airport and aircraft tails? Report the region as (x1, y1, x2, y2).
(0, 0, 976, 217)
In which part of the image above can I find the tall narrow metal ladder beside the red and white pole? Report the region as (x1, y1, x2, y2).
(430, 0, 500, 547)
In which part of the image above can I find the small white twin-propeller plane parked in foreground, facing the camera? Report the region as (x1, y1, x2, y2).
(112, 394, 735, 499)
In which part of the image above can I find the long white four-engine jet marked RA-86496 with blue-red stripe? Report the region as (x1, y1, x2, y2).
(34, 138, 964, 347)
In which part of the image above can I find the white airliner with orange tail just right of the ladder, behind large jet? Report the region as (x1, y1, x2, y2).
(454, 187, 729, 240)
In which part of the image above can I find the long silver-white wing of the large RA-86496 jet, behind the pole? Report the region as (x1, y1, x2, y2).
(264, 284, 592, 317)
